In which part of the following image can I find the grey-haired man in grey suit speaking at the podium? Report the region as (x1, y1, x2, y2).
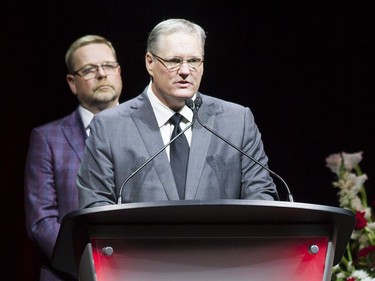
(77, 19, 278, 208)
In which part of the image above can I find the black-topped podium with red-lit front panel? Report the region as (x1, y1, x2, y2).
(52, 200, 355, 281)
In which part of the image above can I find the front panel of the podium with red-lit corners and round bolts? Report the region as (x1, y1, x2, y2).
(91, 234, 328, 281)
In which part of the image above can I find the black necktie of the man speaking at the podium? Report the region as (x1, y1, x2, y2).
(169, 113, 189, 199)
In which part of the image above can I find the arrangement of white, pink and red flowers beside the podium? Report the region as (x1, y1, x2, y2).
(326, 151, 375, 281)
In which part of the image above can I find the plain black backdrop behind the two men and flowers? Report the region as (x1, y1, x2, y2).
(0, 0, 375, 280)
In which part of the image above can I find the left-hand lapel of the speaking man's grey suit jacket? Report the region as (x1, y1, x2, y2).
(132, 94, 179, 200)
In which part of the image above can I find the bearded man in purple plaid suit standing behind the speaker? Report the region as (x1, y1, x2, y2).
(25, 35, 122, 280)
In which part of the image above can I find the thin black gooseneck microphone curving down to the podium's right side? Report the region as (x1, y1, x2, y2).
(186, 97, 294, 202)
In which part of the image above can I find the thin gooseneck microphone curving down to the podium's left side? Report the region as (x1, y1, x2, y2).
(117, 99, 199, 204)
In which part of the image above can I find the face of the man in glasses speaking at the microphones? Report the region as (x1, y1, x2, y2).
(146, 32, 203, 110)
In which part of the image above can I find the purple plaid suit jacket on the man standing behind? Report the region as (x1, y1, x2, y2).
(25, 109, 86, 280)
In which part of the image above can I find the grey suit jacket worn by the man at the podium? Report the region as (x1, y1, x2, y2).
(77, 89, 278, 208)
